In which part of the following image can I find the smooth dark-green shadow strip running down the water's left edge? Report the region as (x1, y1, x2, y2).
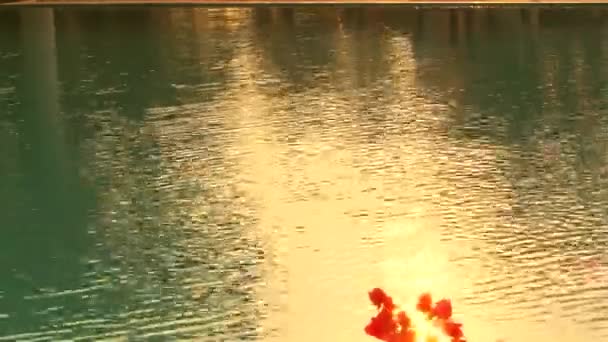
(0, 9, 93, 332)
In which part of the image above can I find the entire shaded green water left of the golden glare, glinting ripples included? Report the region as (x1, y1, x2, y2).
(0, 9, 263, 340)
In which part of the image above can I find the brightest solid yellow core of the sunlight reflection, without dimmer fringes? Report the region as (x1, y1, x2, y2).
(215, 19, 504, 341)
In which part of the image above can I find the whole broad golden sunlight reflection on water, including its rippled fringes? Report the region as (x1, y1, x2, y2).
(115, 11, 608, 342)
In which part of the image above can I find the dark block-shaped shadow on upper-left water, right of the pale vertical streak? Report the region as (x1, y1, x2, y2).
(57, 9, 180, 121)
